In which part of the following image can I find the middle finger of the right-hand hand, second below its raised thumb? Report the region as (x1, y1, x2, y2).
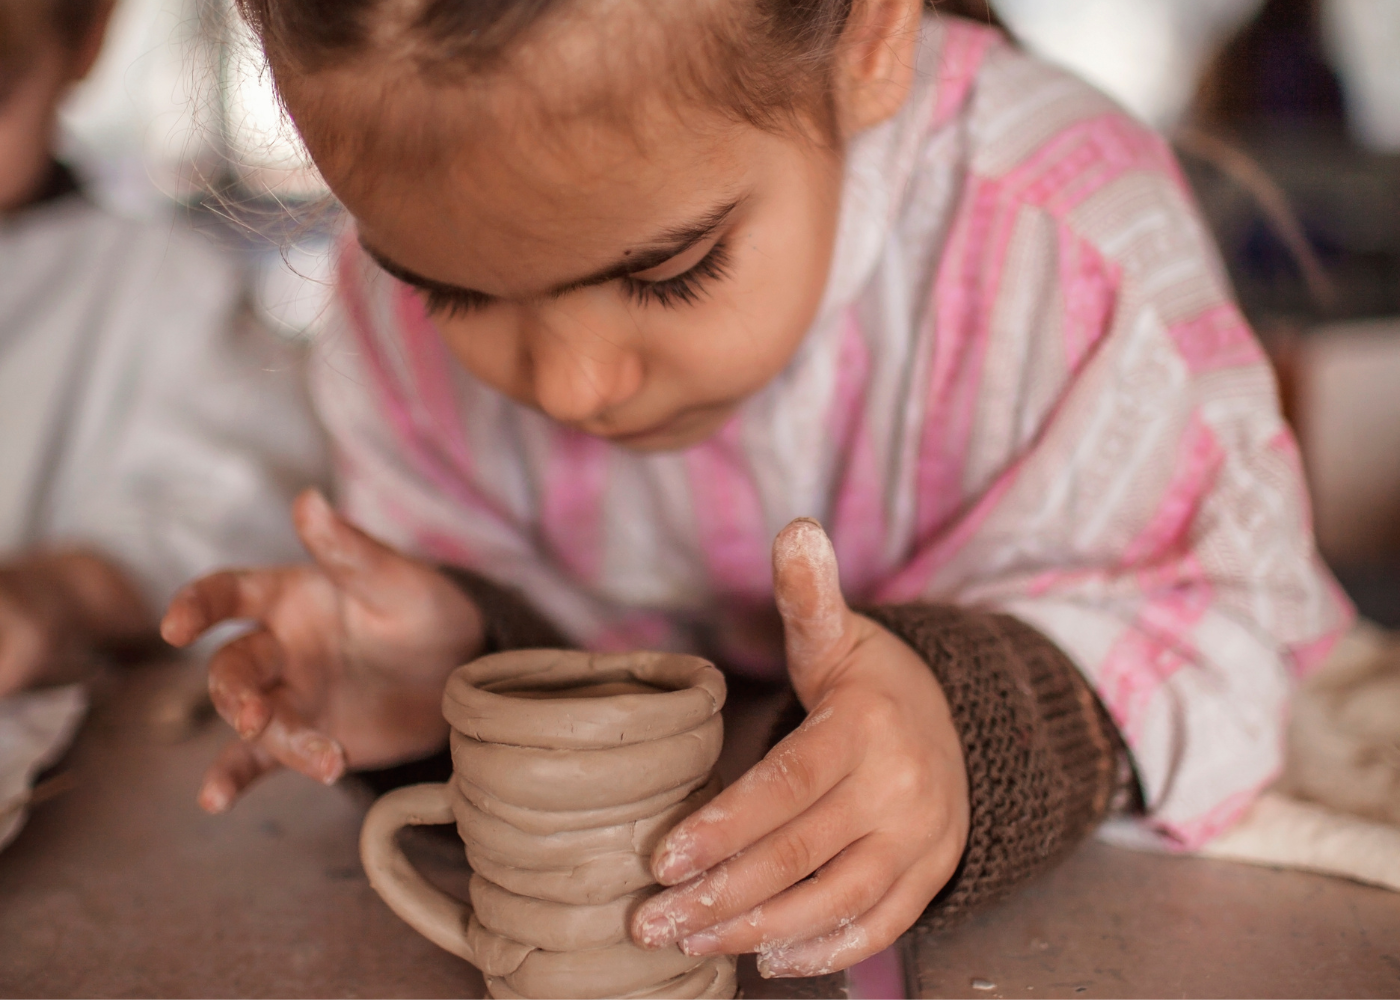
(633, 761, 868, 948)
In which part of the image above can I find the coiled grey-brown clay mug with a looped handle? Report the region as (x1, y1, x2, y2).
(360, 650, 735, 997)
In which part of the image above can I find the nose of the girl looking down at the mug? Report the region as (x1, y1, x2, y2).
(528, 311, 643, 424)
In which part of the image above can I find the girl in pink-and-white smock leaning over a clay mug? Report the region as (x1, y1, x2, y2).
(165, 0, 1348, 976)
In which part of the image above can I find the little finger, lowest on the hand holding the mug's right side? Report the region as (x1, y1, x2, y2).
(759, 870, 932, 979)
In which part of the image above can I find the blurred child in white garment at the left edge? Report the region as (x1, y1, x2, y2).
(0, 0, 323, 696)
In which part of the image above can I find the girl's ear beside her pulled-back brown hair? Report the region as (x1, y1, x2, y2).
(833, 0, 924, 139)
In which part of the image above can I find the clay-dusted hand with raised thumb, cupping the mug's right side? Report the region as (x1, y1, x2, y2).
(631, 518, 969, 978)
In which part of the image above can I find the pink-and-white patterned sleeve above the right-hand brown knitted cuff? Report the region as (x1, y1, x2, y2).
(874, 48, 1351, 849)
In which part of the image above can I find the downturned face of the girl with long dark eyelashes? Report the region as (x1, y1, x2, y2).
(288, 78, 841, 451)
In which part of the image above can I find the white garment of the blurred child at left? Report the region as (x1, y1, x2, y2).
(0, 187, 325, 611)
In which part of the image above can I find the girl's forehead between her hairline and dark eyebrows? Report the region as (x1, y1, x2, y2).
(288, 60, 756, 297)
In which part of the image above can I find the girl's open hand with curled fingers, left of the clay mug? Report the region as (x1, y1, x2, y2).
(161, 490, 484, 812)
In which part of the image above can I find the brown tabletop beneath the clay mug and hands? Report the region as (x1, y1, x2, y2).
(0, 664, 1400, 997)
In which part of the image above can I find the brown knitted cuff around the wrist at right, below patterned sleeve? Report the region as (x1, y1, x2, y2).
(862, 604, 1126, 930)
